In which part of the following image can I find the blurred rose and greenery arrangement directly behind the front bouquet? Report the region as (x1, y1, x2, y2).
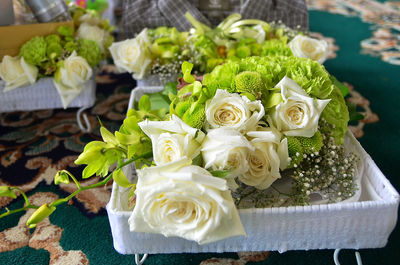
(110, 13, 328, 80)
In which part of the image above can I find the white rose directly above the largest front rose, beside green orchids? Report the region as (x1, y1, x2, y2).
(139, 115, 204, 165)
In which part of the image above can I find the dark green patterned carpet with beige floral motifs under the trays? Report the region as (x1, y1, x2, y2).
(0, 0, 400, 265)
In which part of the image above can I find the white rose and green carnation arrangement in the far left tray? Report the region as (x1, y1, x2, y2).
(0, 7, 114, 108)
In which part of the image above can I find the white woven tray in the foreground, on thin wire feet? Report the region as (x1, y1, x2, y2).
(107, 87, 399, 254)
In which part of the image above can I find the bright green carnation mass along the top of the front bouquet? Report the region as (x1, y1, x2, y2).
(203, 56, 349, 145)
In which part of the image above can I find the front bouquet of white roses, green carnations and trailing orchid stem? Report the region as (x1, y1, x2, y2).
(0, 52, 358, 244)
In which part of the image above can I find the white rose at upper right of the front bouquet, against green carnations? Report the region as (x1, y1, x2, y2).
(272, 76, 330, 137)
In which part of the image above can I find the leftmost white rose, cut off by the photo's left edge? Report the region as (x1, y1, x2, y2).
(0, 55, 38, 92)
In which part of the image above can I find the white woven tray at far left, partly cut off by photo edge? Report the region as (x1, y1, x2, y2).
(0, 78, 96, 113)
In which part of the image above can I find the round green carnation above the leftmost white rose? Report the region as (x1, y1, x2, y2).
(19, 36, 47, 66)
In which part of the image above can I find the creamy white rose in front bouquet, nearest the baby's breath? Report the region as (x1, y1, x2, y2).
(239, 128, 288, 189)
